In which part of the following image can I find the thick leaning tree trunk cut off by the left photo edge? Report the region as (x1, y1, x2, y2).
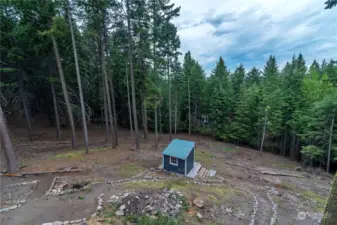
(0, 106, 19, 173)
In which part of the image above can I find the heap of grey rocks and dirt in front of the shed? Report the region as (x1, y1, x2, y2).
(109, 189, 186, 217)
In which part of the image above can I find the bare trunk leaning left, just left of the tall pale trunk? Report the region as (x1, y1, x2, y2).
(51, 35, 76, 148)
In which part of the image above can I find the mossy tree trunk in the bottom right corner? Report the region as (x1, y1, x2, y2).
(321, 173, 337, 225)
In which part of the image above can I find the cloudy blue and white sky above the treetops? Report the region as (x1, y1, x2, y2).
(173, 0, 337, 72)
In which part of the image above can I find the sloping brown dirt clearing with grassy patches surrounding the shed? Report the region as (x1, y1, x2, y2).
(0, 127, 332, 225)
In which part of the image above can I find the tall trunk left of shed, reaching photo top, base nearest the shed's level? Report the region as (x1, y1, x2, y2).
(126, 0, 140, 150)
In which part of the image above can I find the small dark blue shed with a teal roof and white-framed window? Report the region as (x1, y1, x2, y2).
(163, 139, 195, 175)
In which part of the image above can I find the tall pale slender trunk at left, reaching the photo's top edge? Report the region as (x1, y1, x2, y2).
(67, 1, 89, 154)
